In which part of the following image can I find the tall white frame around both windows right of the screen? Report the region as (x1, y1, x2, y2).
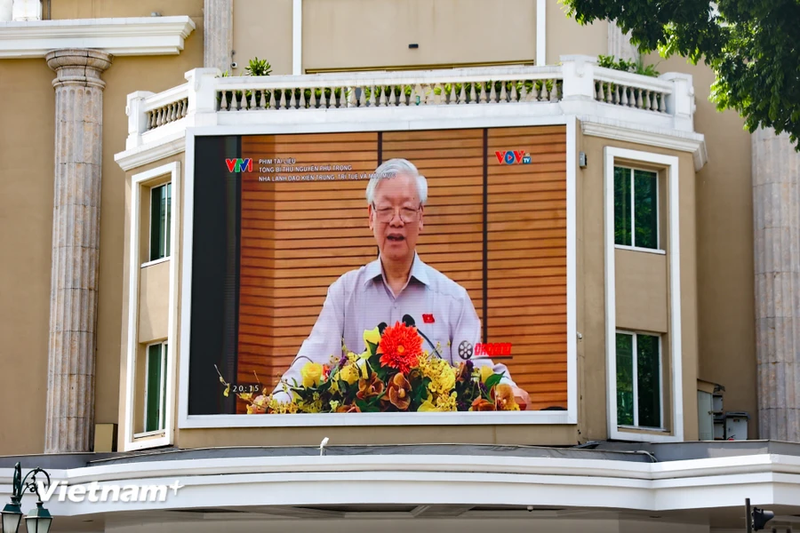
(603, 146, 684, 442)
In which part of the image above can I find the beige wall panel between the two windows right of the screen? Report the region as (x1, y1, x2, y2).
(614, 250, 669, 333)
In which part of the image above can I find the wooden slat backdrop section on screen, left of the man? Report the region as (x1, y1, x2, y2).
(238, 133, 378, 390)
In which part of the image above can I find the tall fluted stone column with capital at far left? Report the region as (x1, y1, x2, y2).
(44, 49, 111, 453)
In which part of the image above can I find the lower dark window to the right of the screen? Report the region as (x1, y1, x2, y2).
(617, 333, 663, 429)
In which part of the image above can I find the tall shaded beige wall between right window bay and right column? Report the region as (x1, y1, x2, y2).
(647, 55, 758, 439)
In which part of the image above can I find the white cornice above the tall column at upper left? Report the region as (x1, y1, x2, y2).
(0, 15, 195, 59)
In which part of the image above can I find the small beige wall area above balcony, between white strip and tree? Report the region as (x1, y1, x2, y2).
(546, 0, 608, 65)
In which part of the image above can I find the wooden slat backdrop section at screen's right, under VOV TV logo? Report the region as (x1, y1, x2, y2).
(487, 126, 567, 409)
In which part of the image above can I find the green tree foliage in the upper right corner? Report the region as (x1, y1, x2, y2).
(562, 0, 800, 150)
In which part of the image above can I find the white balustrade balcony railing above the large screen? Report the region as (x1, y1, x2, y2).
(127, 56, 694, 149)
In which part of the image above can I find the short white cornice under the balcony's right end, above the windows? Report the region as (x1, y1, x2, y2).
(578, 116, 708, 172)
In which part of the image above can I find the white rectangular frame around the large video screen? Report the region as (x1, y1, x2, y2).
(173, 115, 578, 429)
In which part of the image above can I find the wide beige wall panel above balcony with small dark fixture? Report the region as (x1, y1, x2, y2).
(296, 0, 536, 69)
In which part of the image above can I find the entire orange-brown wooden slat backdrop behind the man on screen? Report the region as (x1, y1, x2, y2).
(238, 126, 567, 412)
